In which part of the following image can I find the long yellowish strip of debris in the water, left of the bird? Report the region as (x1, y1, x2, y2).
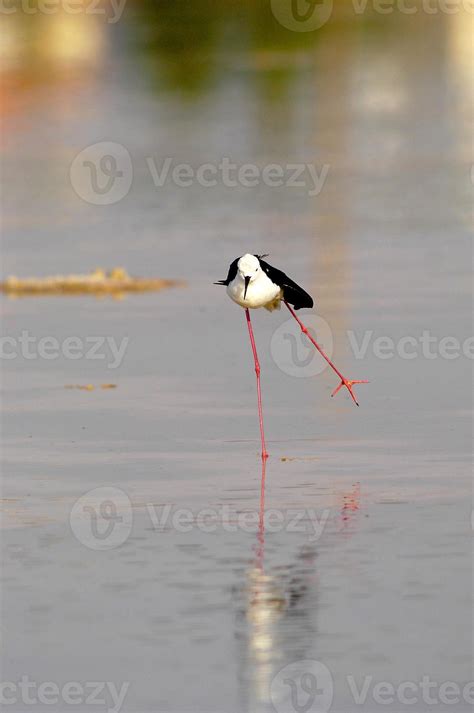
(0, 267, 184, 297)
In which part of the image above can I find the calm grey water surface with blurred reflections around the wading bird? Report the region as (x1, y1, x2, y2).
(1, 2, 473, 713)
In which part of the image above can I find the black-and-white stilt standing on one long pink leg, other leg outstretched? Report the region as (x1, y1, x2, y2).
(214, 253, 369, 461)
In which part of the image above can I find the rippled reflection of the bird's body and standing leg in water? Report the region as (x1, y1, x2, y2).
(236, 462, 317, 713)
